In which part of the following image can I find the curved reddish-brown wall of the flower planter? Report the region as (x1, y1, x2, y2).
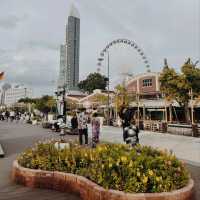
(12, 161, 194, 200)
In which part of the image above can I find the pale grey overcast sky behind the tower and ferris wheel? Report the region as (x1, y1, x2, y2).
(0, 0, 200, 96)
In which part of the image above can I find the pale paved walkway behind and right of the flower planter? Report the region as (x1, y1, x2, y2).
(90, 127, 200, 166)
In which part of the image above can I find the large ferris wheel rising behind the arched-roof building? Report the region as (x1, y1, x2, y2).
(97, 39, 151, 72)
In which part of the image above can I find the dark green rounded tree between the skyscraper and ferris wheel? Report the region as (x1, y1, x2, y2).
(78, 72, 107, 93)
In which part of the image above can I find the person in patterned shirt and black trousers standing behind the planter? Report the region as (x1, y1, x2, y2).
(77, 108, 88, 145)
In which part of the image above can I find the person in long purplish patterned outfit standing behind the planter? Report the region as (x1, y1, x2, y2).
(91, 112, 100, 148)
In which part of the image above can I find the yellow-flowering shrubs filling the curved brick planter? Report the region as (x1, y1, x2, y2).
(18, 142, 189, 193)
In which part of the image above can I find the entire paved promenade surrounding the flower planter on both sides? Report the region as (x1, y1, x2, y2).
(0, 122, 200, 200)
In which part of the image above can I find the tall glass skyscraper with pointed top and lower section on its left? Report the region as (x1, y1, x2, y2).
(58, 5, 80, 90)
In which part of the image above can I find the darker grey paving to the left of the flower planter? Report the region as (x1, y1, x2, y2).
(0, 122, 80, 200)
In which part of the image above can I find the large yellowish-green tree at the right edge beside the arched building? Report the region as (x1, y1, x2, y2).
(159, 58, 200, 122)
